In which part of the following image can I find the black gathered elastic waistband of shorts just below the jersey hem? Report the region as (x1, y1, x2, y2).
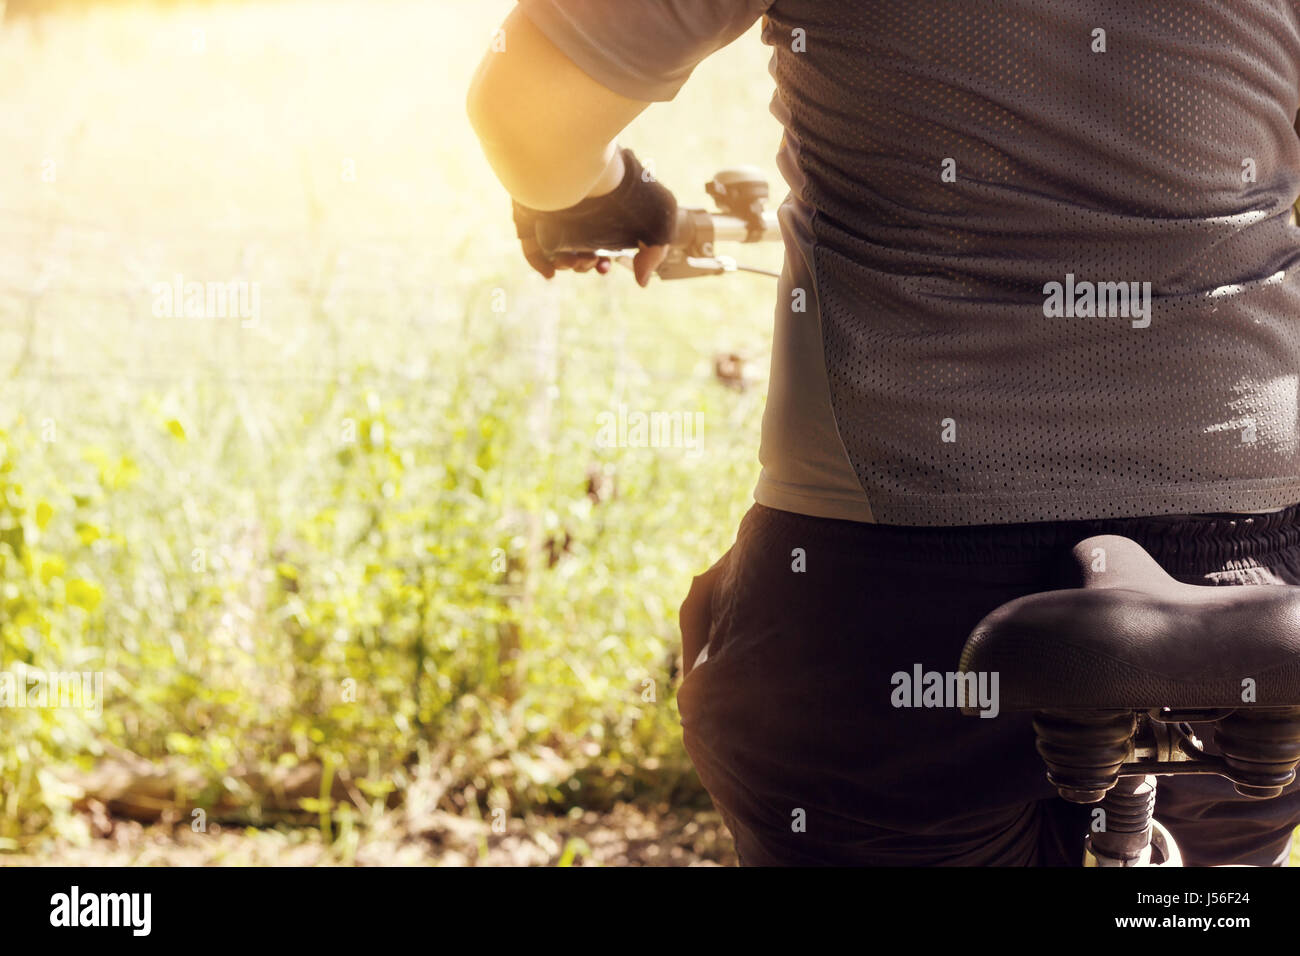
(751, 503, 1300, 575)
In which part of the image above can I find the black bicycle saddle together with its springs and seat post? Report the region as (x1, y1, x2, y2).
(958, 535, 1300, 866)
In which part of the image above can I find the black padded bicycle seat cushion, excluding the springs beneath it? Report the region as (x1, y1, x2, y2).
(959, 535, 1300, 714)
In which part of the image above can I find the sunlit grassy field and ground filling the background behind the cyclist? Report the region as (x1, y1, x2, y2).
(0, 0, 785, 864)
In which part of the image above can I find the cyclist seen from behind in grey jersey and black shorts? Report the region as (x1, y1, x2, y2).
(469, 0, 1300, 865)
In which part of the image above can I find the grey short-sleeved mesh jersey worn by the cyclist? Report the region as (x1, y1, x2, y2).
(521, 0, 1300, 525)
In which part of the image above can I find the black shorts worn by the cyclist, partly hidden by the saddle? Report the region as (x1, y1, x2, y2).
(677, 505, 1300, 866)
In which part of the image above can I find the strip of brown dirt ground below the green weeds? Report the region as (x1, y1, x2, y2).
(0, 804, 736, 866)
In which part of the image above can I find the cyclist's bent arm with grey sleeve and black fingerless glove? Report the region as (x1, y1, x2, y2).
(468, 0, 772, 285)
